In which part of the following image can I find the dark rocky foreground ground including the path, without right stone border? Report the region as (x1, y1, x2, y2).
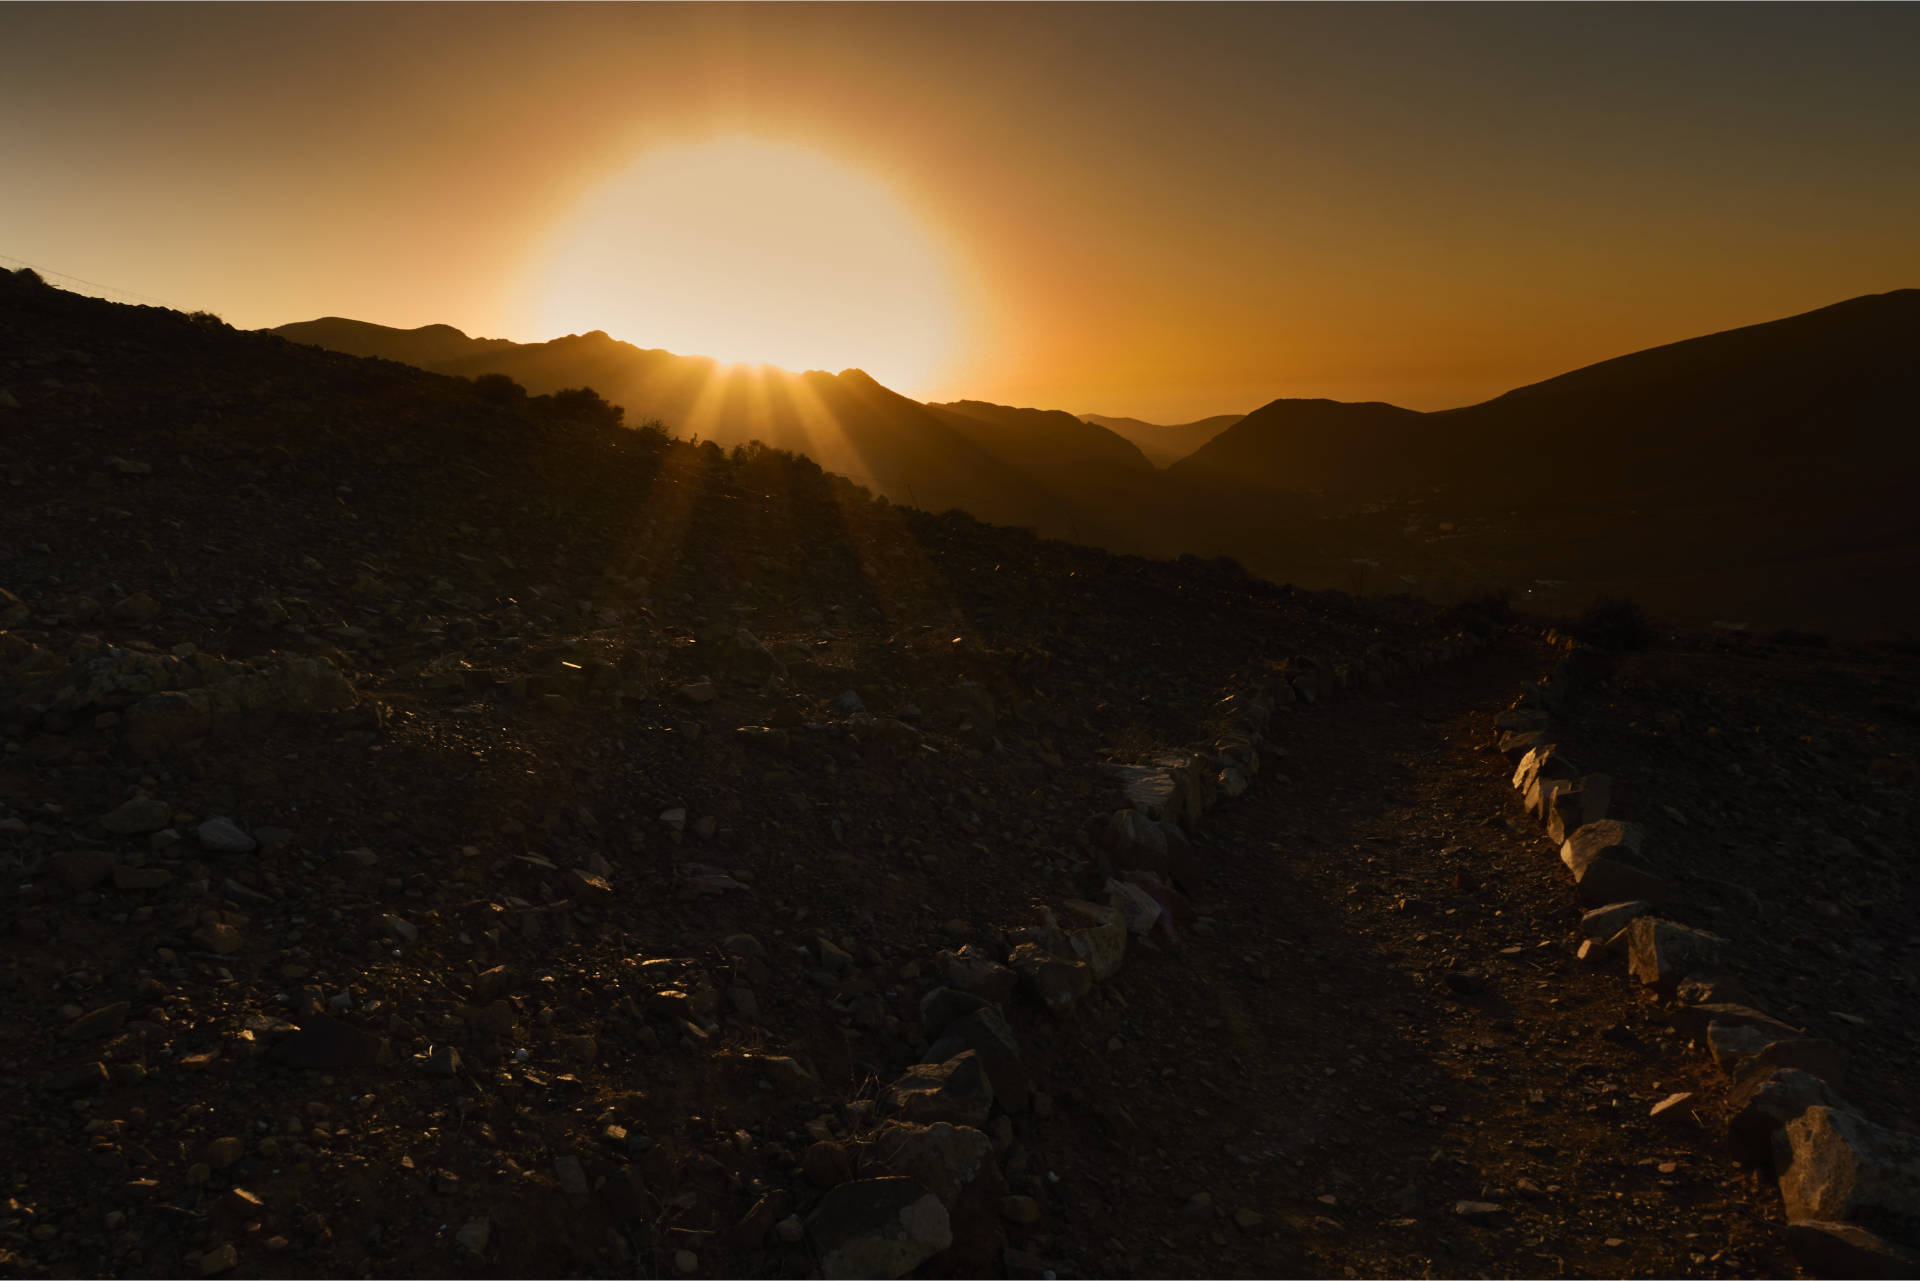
(0, 265, 1914, 1275)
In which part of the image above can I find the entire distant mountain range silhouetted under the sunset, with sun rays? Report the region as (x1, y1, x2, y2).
(275, 288, 1920, 634)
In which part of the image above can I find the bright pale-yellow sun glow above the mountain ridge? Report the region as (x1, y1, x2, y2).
(532, 138, 958, 394)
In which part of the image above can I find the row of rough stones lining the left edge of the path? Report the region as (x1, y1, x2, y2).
(794, 632, 1490, 1277)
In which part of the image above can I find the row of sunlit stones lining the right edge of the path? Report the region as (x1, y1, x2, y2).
(1494, 632, 1920, 1277)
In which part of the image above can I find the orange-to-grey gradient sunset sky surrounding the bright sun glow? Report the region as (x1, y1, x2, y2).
(0, 4, 1920, 421)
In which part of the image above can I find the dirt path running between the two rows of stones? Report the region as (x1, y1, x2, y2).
(1016, 640, 1797, 1277)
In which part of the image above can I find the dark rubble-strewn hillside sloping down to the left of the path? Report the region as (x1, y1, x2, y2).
(0, 268, 1482, 1275)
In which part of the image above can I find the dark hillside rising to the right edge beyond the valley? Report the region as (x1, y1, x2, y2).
(1167, 290, 1920, 638)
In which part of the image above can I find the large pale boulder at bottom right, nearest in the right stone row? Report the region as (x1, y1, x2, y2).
(1774, 1106, 1920, 1246)
